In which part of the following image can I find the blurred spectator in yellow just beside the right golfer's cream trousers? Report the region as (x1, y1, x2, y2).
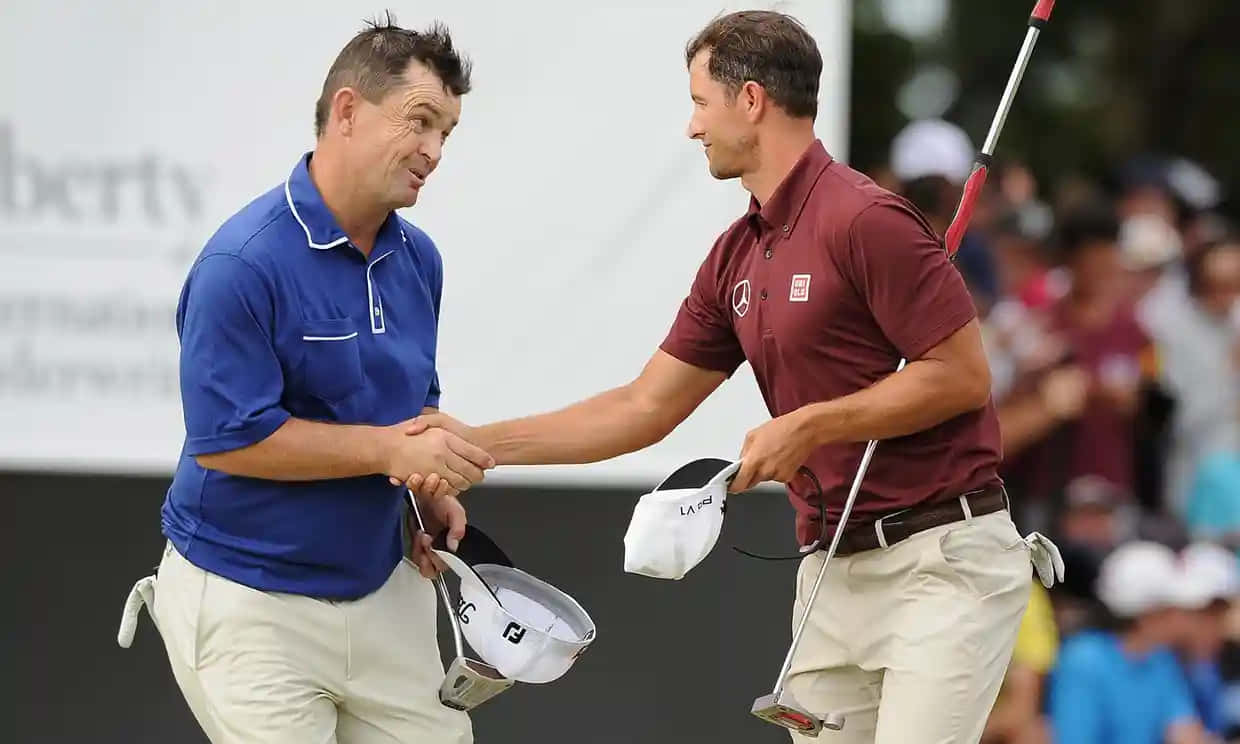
(981, 582, 1059, 744)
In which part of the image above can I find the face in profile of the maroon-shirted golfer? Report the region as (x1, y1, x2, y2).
(686, 50, 760, 180)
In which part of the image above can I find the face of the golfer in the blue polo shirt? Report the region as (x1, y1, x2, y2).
(337, 61, 461, 210)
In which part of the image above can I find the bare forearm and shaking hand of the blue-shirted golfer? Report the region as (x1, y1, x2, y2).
(196, 418, 494, 490)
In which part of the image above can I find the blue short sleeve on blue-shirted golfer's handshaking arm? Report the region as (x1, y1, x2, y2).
(177, 254, 289, 455)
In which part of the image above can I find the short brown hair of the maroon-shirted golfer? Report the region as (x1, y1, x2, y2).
(684, 10, 822, 119)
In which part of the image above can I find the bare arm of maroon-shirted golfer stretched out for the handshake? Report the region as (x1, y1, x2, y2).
(460, 350, 727, 465)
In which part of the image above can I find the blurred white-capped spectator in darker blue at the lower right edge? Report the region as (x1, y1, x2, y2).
(1178, 542, 1240, 737)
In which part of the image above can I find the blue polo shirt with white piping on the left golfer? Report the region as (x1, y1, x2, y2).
(162, 154, 443, 599)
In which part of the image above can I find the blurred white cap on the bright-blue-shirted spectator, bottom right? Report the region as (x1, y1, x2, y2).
(1095, 541, 1180, 618)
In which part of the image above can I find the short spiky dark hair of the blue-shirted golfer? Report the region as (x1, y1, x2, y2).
(314, 11, 471, 136)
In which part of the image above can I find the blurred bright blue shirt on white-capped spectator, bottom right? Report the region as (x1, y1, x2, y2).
(1049, 631, 1197, 744)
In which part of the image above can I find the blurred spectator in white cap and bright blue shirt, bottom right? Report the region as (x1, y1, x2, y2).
(1049, 542, 1208, 744)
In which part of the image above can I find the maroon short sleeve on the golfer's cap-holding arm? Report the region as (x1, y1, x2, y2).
(847, 202, 977, 360)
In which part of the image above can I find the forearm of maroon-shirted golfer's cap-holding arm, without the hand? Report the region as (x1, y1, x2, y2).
(802, 358, 990, 445)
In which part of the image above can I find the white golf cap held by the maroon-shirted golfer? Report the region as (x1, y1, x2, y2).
(624, 458, 740, 579)
